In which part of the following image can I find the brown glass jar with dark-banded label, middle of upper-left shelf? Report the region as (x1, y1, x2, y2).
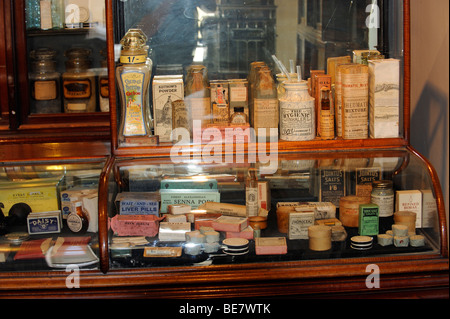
(62, 48, 96, 113)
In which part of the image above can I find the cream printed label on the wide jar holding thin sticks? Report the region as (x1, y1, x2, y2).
(280, 100, 315, 141)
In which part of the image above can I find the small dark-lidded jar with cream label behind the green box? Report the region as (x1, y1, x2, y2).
(370, 180, 394, 234)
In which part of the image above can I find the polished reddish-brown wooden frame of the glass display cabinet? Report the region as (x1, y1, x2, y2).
(0, 0, 449, 299)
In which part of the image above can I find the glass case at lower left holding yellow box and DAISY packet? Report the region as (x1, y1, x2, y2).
(0, 159, 105, 273)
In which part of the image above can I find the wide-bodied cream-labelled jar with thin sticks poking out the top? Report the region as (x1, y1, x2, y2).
(280, 81, 316, 141)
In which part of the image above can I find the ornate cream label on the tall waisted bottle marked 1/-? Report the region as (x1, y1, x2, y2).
(120, 71, 147, 136)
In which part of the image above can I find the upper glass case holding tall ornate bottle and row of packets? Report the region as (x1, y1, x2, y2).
(108, 0, 409, 155)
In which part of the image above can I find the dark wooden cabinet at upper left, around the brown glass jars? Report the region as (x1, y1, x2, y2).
(0, 0, 110, 143)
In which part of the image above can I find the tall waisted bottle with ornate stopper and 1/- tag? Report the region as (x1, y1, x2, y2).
(116, 29, 152, 143)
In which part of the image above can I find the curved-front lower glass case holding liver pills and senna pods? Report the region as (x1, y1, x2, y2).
(103, 149, 445, 270)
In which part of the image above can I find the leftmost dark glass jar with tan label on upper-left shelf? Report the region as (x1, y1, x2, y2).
(29, 48, 61, 114)
